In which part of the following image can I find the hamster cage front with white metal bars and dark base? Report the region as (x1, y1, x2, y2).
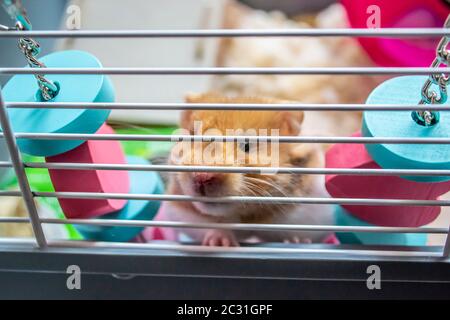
(0, 0, 450, 299)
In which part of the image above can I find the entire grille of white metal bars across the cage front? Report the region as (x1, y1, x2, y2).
(0, 28, 450, 257)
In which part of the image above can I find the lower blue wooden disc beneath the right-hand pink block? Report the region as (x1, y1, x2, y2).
(334, 206, 427, 246)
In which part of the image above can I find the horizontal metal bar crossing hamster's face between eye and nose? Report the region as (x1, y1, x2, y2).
(25, 162, 450, 176)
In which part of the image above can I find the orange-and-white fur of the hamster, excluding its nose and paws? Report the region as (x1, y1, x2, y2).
(165, 93, 334, 245)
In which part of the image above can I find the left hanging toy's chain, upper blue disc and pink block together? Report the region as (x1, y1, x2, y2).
(3, 0, 130, 224)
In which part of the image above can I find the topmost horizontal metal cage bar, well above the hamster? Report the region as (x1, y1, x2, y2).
(0, 28, 450, 38)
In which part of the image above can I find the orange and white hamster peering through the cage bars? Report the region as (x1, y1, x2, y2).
(164, 93, 333, 246)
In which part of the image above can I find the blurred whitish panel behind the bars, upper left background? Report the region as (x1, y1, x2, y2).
(58, 0, 225, 123)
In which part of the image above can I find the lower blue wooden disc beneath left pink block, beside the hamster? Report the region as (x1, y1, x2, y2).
(75, 157, 164, 242)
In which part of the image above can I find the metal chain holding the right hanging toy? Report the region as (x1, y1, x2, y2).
(413, 15, 450, 127)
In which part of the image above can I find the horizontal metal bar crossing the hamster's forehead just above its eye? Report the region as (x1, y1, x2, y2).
(5, 132, 450, 144)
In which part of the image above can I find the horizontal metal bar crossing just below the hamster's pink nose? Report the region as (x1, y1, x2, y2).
(33, 192, 450, 206)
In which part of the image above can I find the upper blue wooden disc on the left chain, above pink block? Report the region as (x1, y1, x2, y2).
(2, 51, 115, 157)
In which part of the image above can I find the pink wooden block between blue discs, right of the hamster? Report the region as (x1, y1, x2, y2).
(325, 133, 450, 227)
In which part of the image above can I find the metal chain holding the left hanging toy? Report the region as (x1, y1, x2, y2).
(2, 0, 59, 101)
